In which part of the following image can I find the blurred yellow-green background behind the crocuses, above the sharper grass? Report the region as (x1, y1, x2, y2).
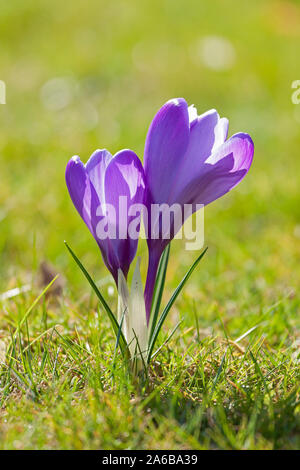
(0, 0, 300, 308)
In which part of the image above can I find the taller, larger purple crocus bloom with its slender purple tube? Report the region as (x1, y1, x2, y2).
(144, 98, 254, 322)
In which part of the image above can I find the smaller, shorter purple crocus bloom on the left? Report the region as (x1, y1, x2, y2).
(66, 150, 145, 284)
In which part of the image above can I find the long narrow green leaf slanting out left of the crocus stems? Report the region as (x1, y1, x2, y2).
(65, 242, 130, 359)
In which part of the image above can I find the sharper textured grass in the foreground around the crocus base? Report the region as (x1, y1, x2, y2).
(1, 284, 299, 449)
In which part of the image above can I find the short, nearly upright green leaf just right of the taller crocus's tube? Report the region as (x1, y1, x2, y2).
(149, 243, 171, 341)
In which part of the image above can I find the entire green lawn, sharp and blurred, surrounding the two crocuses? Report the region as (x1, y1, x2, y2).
(0, 0, 300, 449)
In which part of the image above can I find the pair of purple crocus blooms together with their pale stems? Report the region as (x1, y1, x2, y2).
(66, 98, 254, 370)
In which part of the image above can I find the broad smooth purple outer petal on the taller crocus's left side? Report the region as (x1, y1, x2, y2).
(144, 98, 190, 203)
